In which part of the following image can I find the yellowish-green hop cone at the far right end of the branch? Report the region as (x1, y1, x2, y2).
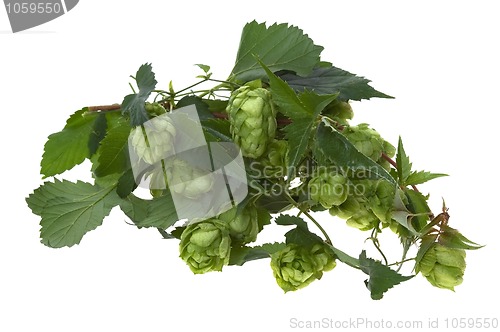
(415, 243, 466, 290)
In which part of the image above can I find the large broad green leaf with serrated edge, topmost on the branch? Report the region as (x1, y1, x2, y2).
(229, 21, 323, 83)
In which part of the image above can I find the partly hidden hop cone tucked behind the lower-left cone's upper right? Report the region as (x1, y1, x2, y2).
(218, 204, 259, 244)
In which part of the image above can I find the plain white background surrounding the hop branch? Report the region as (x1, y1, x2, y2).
(0, 0, 500, 332)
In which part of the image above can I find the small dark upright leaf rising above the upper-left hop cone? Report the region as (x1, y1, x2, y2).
(122, 63, 157, 127)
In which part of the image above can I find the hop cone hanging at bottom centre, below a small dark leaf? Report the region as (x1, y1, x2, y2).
(271, 243, 336, 292)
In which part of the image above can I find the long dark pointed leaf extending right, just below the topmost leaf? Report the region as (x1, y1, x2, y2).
(280, 65, 394, 101)
